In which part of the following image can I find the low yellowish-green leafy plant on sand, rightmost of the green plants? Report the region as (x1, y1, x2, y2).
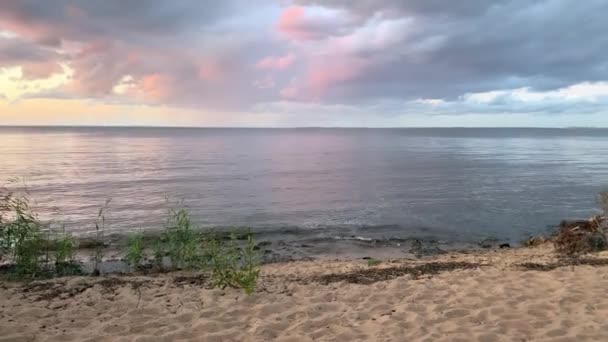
(207, 234, 260, 294)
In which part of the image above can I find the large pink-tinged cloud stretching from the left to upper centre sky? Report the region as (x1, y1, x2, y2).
(0, 3, 385, 106)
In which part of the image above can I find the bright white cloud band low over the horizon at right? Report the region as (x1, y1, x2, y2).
(253, 82, 608, 121)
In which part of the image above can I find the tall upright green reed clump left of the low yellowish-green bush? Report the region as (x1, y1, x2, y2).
(162, 208, 202, 269)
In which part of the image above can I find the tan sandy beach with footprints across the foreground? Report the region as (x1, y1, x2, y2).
(0, 244, 608, 342)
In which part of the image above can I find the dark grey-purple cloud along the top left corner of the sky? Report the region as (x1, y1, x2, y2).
(0, 0, 239, 41)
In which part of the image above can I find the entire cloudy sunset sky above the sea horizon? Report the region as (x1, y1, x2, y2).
(0, 0, 608, 127)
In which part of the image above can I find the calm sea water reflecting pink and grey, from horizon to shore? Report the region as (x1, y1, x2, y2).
(0, 127, 608, 241)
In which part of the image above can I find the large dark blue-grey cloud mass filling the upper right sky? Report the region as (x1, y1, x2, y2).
(290, 0, 608, 101)
